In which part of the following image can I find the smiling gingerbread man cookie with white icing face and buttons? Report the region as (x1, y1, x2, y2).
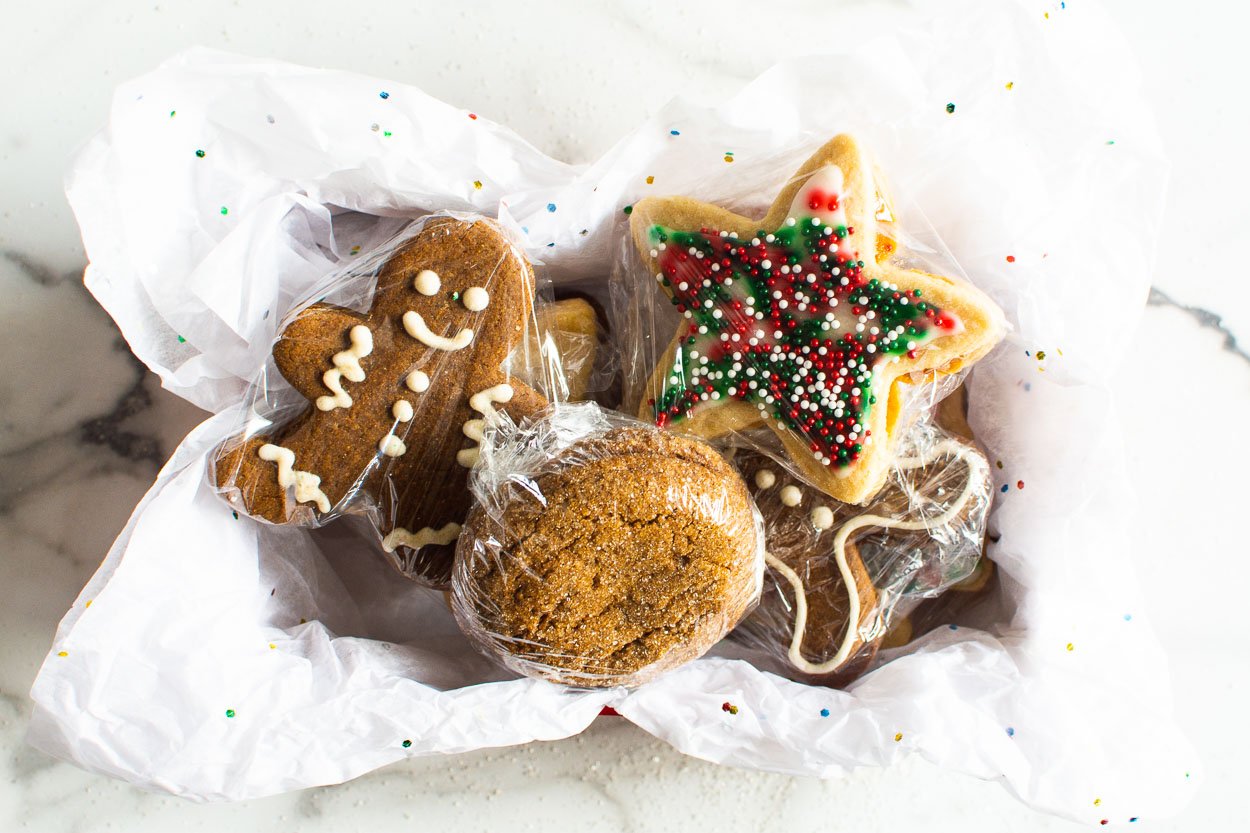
(211, 218, 546, 585)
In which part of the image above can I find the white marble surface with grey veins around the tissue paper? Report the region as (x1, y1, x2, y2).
(0, 0, 1250, 830)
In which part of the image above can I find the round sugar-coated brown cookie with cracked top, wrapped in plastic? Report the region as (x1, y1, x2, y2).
(453, 428, 763, 688)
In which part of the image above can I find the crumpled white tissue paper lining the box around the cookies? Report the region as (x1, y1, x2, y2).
(29, 0, 1199, 823)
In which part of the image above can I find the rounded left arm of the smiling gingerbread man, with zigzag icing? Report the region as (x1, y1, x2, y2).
(274, 304, 373, 403)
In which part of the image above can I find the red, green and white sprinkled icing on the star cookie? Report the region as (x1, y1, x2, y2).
(650, 188, 959, 468)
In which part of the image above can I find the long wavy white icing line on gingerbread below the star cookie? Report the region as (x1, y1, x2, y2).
(764, 440, 985, 674)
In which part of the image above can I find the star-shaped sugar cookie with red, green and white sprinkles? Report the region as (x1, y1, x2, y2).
(630, 135, 1004, 504)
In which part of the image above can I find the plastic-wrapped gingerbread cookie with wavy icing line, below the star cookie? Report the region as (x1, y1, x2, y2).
(734, 423, 991, 685)
